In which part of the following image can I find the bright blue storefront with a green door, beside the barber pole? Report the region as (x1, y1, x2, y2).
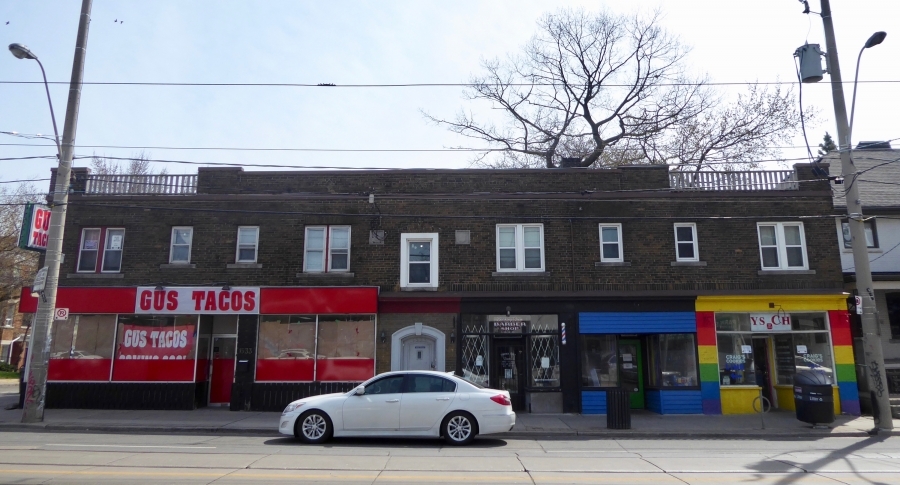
(579, 311, 703, 414)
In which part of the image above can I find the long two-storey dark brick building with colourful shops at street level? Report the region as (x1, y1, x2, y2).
(15, 165, 859, 414)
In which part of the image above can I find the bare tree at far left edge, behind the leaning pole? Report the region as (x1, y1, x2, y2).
(0, 183, 40, 299)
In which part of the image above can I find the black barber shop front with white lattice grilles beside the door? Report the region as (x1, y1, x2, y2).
(458, 315, 562, 412)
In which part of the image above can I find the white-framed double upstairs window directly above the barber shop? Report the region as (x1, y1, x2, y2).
(497, 224, 544, 271)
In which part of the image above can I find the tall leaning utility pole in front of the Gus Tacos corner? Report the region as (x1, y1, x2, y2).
(22, 0, 92, 423)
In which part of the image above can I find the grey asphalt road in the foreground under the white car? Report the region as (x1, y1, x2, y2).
(0, 431, 900, 485)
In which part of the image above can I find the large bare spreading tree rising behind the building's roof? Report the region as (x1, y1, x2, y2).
(425, 10, 799, 168)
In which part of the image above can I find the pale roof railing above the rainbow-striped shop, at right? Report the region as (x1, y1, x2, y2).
(669, 170, 799, 190)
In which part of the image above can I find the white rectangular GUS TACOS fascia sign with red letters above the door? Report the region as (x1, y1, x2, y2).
(134, 286, 259, 315)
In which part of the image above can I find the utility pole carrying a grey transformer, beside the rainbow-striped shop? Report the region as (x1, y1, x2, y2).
(821, 0, 894, 430)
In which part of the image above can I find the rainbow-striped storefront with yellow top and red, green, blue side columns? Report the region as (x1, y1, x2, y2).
(697, 295, 859, 414)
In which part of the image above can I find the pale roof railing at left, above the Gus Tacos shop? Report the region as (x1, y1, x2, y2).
(84, 174, 197, 195)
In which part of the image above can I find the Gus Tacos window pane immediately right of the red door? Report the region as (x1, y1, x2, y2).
(256, 315, 316, 382)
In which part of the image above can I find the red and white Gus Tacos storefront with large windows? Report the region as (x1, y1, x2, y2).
(22, 286, 378, 409)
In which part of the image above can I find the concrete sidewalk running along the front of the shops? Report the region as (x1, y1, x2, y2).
(0, 386, 900, 439)
